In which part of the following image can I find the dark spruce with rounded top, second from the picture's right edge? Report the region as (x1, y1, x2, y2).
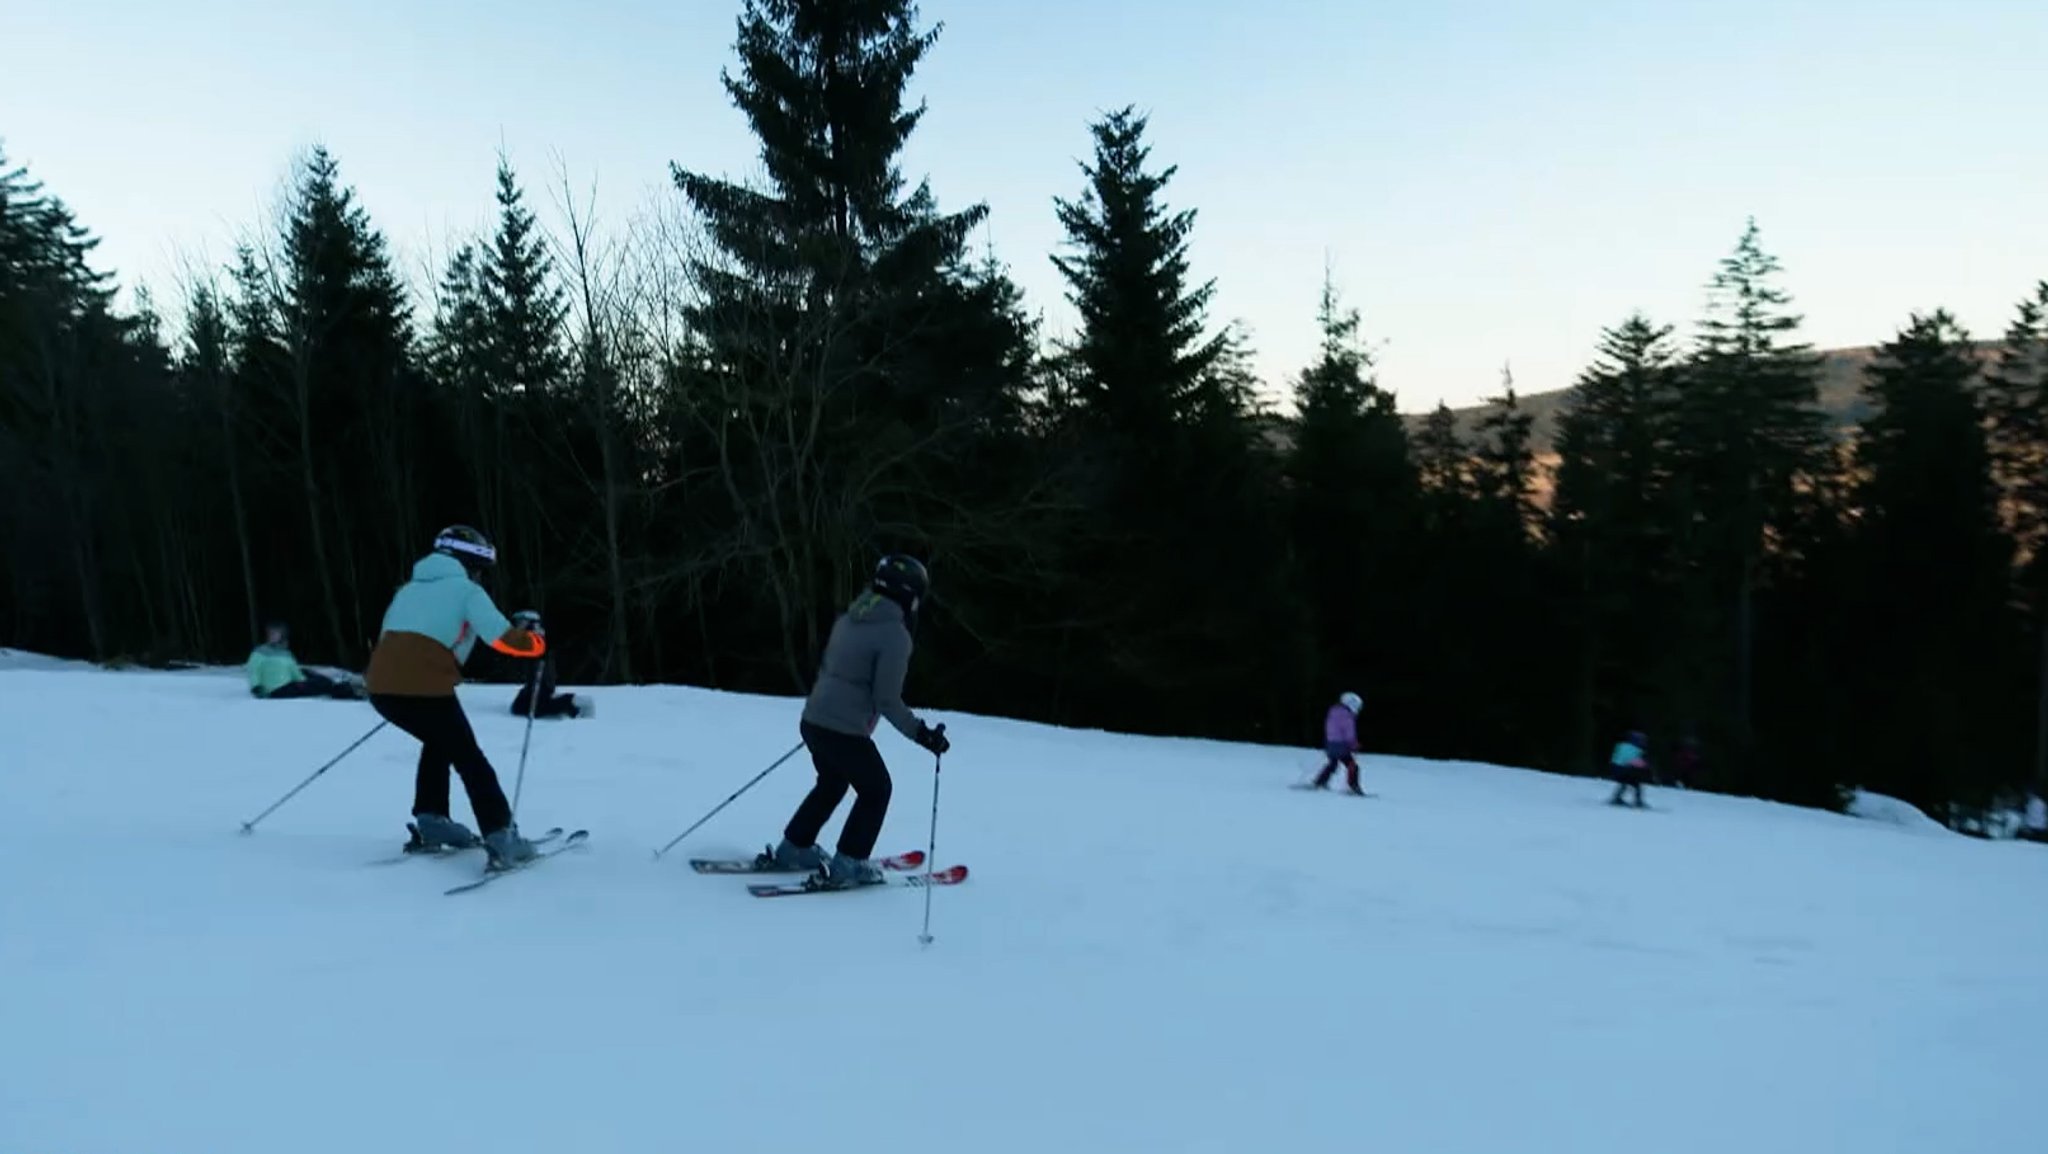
(1858, 310, 2017, 812)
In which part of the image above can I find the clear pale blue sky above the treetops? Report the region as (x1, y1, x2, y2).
(0, 0, 2048, 410)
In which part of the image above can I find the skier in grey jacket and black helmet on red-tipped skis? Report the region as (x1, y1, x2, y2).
(764, 553, 952, 885)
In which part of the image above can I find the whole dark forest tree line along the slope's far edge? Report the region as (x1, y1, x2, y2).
(0, 0, 2048, 826)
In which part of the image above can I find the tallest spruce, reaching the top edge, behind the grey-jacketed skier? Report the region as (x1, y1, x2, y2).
(670, 0, 1026, 685)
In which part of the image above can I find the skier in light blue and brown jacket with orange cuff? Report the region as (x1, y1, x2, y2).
(369, 525, 547, 865)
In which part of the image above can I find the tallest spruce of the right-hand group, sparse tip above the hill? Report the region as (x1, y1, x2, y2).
(1681, 219, 1827, 758)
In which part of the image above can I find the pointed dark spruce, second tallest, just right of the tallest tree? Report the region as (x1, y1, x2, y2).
(1053, 109, 1298, 734)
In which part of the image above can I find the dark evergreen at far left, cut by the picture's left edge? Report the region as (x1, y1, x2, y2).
(0, 156, 205, 660)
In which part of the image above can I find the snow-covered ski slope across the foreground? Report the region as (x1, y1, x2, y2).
(0, 660, 2048, 1154)
